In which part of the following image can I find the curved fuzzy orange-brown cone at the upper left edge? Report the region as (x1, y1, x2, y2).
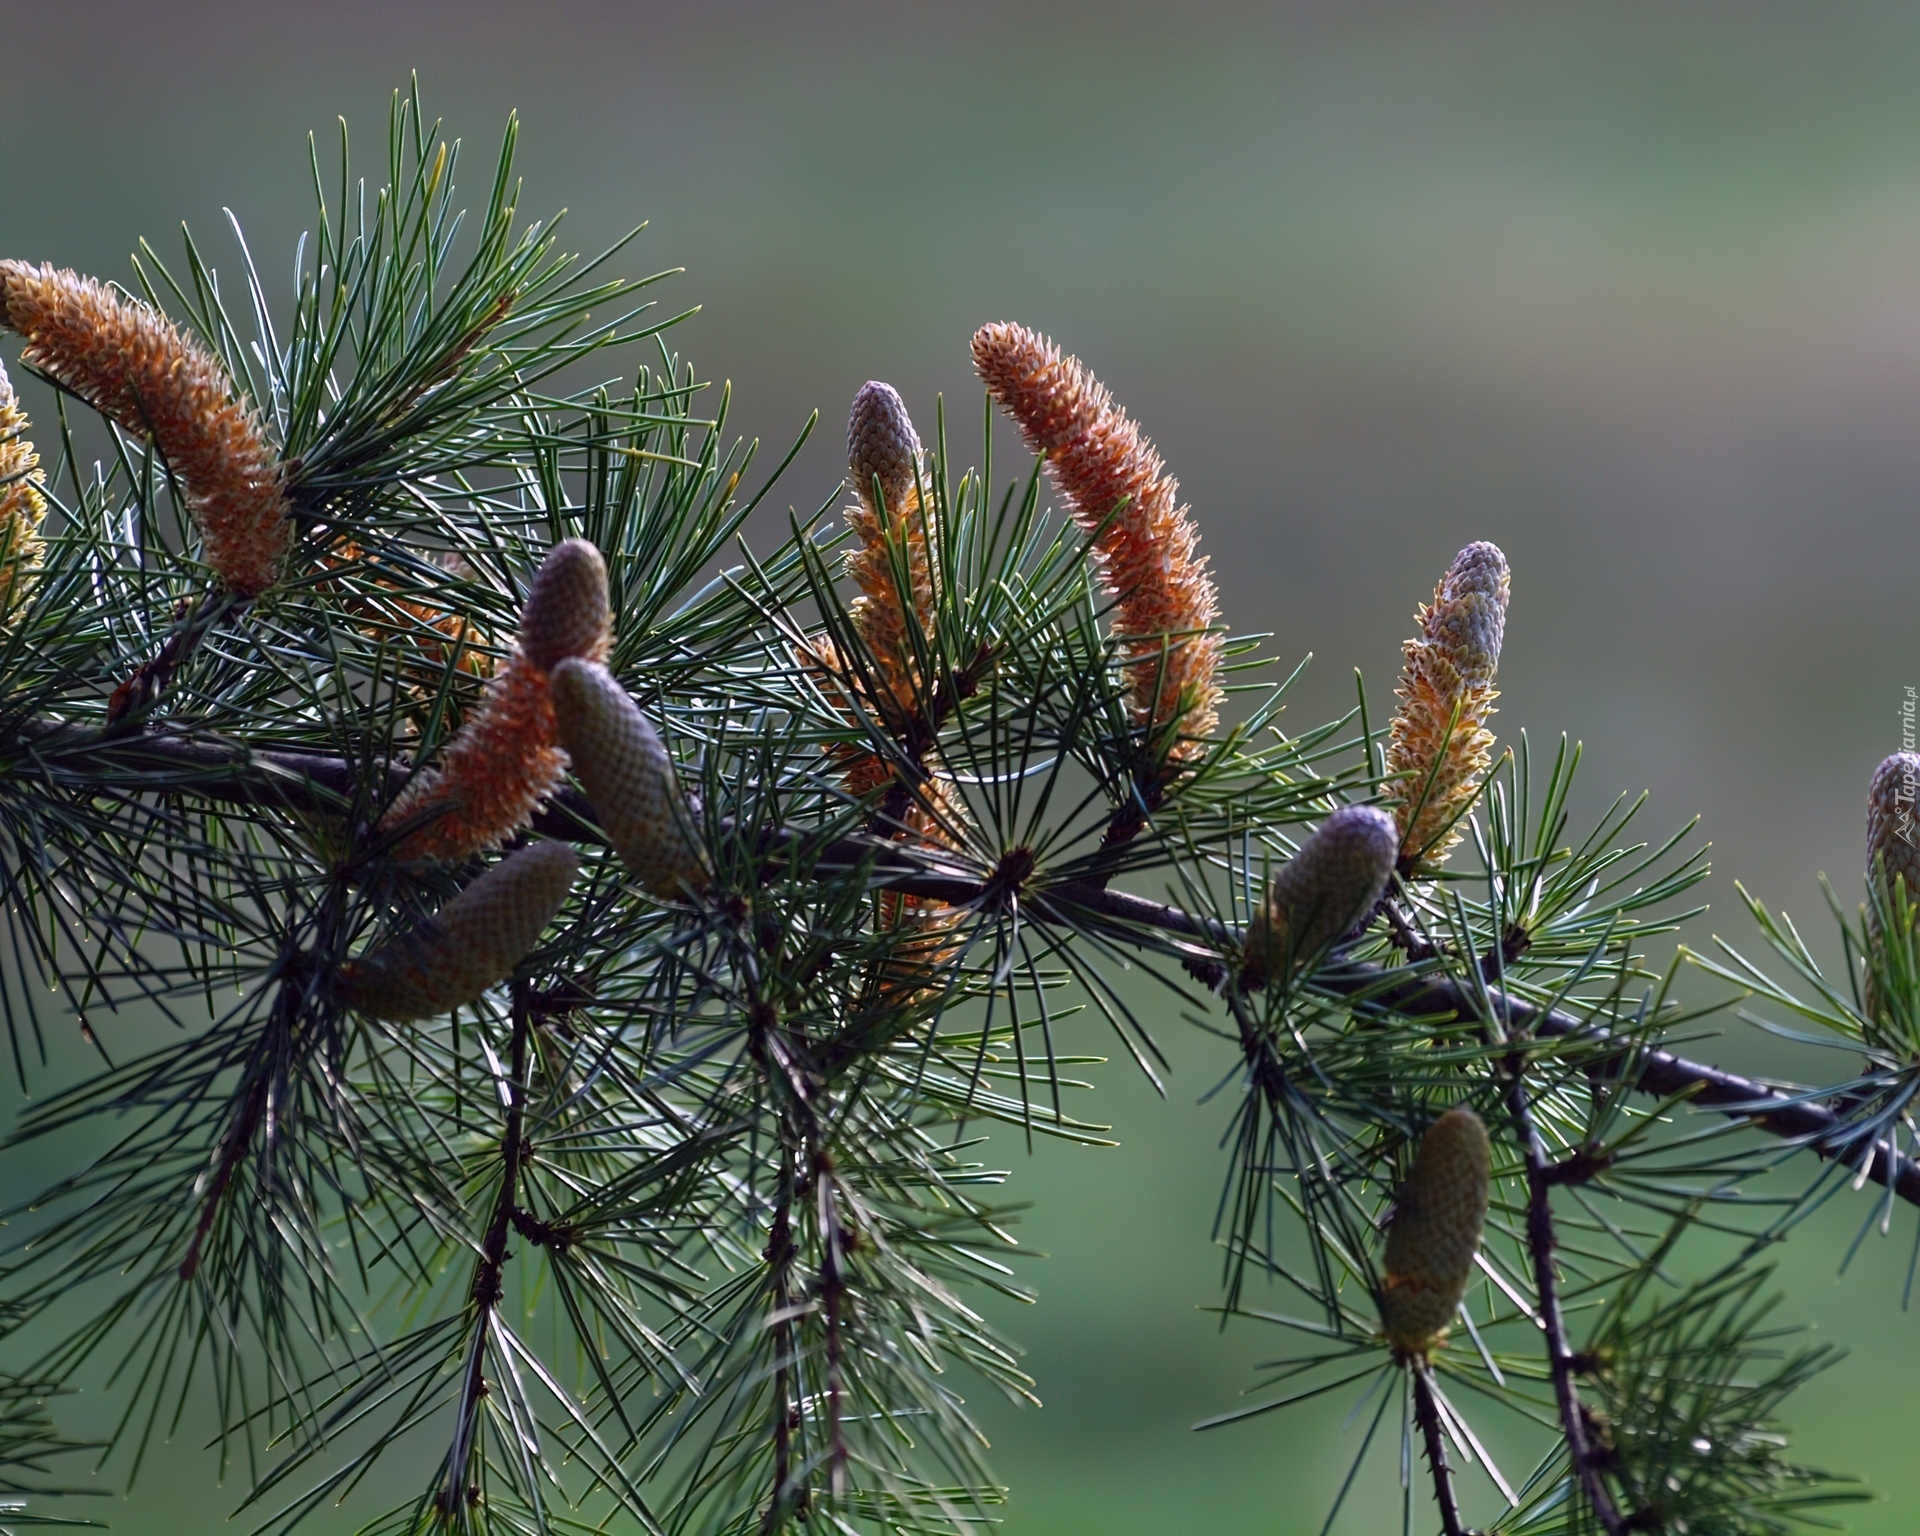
(0, 261, 292, 597)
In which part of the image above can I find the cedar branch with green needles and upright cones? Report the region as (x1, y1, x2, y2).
(0, 86, 1920, 1536)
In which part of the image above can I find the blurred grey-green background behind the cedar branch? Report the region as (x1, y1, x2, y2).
(0, 0, 1920, 1536)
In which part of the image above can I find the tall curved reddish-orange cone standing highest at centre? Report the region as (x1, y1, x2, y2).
(973, 324, 1221, 760)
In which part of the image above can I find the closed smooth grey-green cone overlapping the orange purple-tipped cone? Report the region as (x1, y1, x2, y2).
(547, 659, 707, 897)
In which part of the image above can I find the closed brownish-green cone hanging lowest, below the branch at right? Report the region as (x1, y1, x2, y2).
(1380, 1104, 1494, 1359)
